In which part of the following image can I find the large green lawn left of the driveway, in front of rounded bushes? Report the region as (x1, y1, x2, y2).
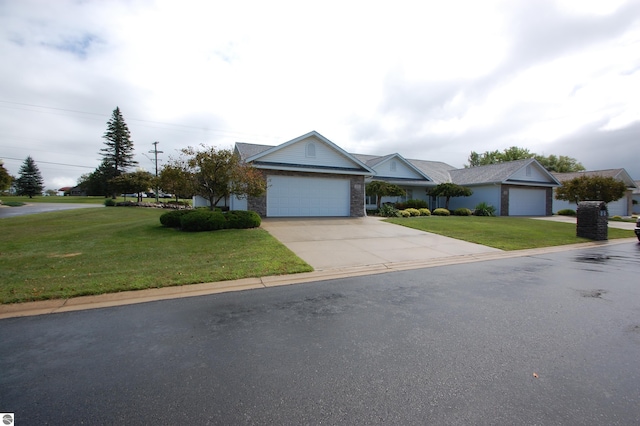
(0, 207, 312, 303)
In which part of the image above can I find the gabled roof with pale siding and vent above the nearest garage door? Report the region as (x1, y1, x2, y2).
(236, 130, 375, 175)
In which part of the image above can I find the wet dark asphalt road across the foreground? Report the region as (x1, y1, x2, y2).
(0, 243, 640, 425)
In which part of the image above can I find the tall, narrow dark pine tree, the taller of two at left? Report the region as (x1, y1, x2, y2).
(100, 107, 138, 177)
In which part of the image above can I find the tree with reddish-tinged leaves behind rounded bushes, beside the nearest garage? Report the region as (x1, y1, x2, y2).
(177, 145, 267, 210)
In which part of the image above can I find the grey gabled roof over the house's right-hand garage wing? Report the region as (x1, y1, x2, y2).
(449, 158, 560, 186)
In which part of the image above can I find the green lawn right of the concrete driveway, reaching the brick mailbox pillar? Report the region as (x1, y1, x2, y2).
(386, 216, 635, 250)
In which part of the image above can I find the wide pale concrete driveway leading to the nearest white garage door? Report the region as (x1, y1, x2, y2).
(262, 217, 501, 270)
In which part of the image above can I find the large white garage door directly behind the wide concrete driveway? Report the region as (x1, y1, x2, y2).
(267, 176, 351, 217)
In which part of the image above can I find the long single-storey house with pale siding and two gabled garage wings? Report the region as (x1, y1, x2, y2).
(194, 131, 560, 217)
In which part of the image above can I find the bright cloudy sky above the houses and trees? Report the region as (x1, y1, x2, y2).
(0, 0, 640, 189)
